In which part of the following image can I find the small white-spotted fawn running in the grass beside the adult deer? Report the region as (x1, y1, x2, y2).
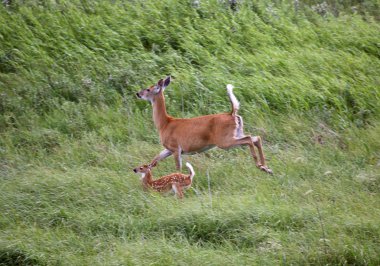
(133, 163, 195, 199)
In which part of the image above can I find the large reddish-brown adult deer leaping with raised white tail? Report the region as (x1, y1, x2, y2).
(136, 76, 272, 174)
